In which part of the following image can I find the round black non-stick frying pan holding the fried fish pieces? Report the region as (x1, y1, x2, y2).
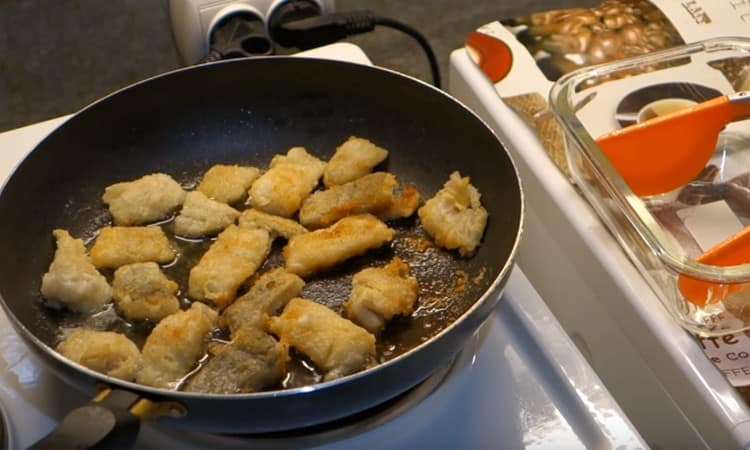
(0, 57, 523, 442)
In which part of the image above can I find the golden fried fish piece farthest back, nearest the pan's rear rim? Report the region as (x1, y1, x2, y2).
(323, 136, 388, 187)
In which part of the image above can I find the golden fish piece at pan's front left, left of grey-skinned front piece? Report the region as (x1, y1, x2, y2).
(136, 302, 218, 389)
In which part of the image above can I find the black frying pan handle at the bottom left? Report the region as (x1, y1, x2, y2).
(30, 389, 156, 450)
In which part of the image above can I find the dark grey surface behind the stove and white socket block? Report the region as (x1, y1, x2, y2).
(0, 0, 598, 131)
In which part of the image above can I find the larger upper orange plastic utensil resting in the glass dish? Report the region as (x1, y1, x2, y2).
(597, 91, 750, 196)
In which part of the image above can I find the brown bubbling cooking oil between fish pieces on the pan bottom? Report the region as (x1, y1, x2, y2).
(54, 200, 486, 389)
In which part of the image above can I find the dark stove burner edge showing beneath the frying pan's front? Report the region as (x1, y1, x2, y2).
(141, 354, 460, 449)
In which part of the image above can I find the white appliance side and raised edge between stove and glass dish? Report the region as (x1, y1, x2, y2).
(449, 40, 750, 449)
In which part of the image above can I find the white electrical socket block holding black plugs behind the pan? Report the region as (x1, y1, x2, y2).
(169, 0, 335, 65)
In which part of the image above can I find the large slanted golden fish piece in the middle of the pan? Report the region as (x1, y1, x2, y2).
(188, 225, 271, 310)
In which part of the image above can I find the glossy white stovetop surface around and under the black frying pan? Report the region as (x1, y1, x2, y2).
(0, 45, 647, 449)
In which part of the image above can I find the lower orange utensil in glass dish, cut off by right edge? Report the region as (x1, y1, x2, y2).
(677, 226, 750, 307)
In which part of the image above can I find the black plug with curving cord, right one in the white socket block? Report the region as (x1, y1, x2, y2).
(269, 7, 440, 88)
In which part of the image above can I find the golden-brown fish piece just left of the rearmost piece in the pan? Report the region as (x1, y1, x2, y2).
(249, 147, 326, 217)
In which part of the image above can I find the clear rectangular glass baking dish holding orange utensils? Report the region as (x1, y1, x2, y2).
(550, 38, 750, 335)
